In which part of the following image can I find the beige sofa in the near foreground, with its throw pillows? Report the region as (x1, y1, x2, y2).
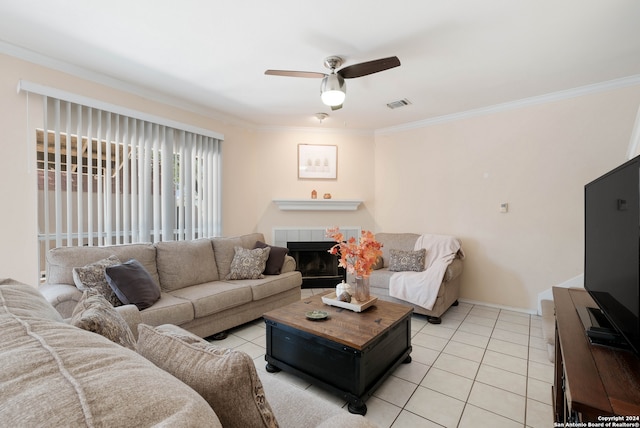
(0, 278, 375, 428)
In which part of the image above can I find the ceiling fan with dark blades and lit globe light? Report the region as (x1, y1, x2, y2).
(264, 56, 400, 110)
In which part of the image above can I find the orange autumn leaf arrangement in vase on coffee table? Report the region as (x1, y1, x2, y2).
(327, 227, 382, 277)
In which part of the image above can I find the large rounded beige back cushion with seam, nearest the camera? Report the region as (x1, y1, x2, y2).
(0, 284, 222, 427)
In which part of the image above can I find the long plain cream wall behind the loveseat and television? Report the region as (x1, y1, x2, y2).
(375, 87, 640, 310)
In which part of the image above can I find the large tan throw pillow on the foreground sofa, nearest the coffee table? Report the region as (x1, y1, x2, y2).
(138, 324, 278, 428)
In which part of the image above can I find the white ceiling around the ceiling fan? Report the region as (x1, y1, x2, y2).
(0, 0, 640, 130)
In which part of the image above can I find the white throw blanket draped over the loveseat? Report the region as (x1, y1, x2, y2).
(389, 235, 464, 310)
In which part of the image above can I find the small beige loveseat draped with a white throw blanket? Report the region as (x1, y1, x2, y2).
(370, 232, 464, 324)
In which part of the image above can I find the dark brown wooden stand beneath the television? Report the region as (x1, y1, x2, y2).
(552, 287, 640, 426)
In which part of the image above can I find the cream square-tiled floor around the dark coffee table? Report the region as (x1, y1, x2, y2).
(216, 289, 553, 428)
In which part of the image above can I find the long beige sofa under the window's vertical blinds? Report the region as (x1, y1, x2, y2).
(40, 233, 302, 337)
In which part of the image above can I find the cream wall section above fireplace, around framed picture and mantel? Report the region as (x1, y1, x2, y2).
(254, 130, 375, 239)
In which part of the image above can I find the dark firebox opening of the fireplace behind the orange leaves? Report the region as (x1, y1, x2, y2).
(287, 241, 346, 288)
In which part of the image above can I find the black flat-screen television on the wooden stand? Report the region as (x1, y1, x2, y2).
(581, 156, 640, 355)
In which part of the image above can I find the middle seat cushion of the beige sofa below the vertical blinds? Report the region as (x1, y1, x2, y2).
(171, 281, 252, 318)
